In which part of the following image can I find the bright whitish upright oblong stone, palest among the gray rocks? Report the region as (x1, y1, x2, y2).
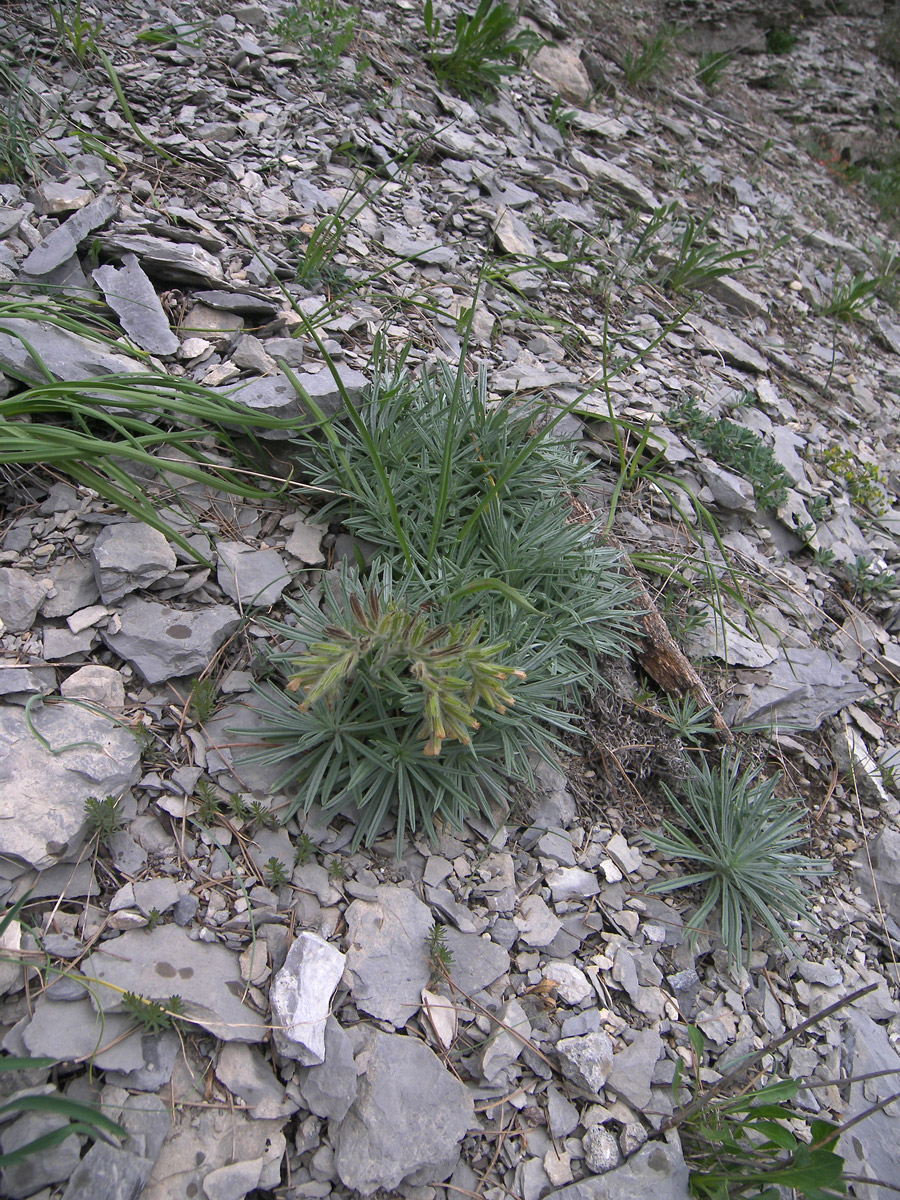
(269, 931, 344, 1067)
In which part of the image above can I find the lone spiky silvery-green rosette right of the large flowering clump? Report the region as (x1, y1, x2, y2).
(646, 751, 832, 964)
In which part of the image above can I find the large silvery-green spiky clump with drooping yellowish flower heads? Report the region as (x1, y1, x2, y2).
(247, 352, 636, 848)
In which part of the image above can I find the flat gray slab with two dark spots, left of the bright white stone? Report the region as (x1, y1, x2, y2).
(83, 925, 266, 1042)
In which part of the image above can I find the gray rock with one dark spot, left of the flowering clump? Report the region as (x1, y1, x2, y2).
(103, 598, 240, 683)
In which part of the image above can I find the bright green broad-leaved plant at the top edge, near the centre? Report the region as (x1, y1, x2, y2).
(424, 0, 544, 97)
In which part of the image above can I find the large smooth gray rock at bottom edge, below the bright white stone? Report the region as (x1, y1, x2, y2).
(335, 1026, 474, 1196)
